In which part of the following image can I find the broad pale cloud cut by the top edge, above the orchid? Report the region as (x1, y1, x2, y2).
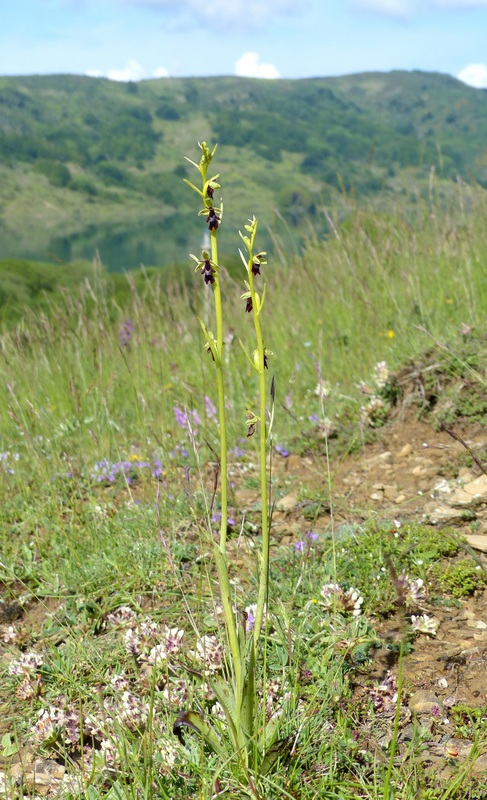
(118, 0, 310, 30)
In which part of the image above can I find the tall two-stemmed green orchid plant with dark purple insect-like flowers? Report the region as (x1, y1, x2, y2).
(174, 142, 282, 799)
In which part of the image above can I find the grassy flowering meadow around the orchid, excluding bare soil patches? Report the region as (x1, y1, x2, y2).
(0, 167, 487, 800)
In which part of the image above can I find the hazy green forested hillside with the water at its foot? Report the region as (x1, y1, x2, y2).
(0, 72, 487, 266)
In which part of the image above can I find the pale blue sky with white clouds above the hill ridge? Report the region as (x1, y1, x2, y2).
(0, 0, 487, 88)
